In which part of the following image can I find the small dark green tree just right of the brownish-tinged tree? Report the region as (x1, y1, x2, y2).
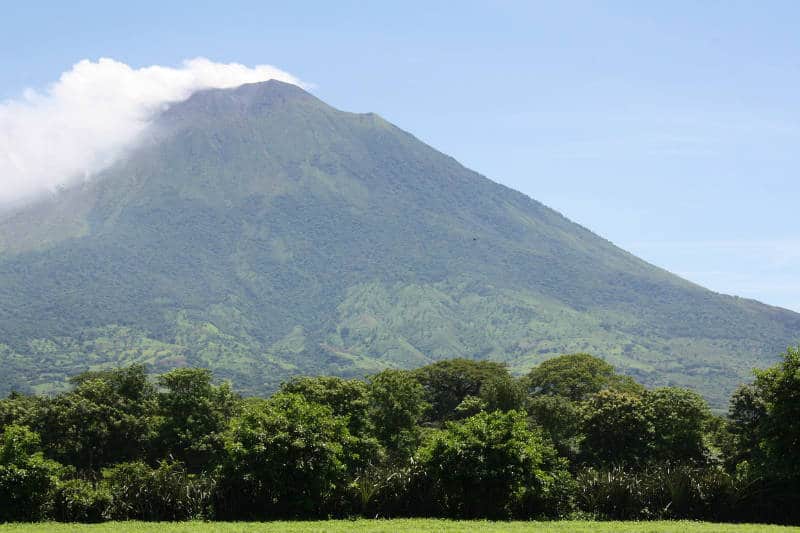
(644, 387, 711, 461)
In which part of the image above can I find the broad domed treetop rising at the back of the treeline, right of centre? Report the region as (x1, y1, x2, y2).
(527, 353, 644, 402)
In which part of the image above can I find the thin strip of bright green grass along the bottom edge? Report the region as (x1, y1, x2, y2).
(0, 520, 800, 533)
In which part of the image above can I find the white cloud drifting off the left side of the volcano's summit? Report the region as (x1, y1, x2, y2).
(0, 58, 301, 205)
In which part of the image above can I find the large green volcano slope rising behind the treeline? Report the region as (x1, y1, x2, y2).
(0, 81, 800, 406)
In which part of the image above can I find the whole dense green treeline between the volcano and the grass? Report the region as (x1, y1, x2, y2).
(0, 349, 800, 523)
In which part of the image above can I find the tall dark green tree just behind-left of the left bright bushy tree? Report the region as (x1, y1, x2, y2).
(158, 368, 238, 471)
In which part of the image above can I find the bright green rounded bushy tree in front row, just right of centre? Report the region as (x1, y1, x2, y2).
(421, 411, 570, 519)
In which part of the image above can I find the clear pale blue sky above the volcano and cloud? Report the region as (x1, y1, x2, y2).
(0, 0, 800, 311)
